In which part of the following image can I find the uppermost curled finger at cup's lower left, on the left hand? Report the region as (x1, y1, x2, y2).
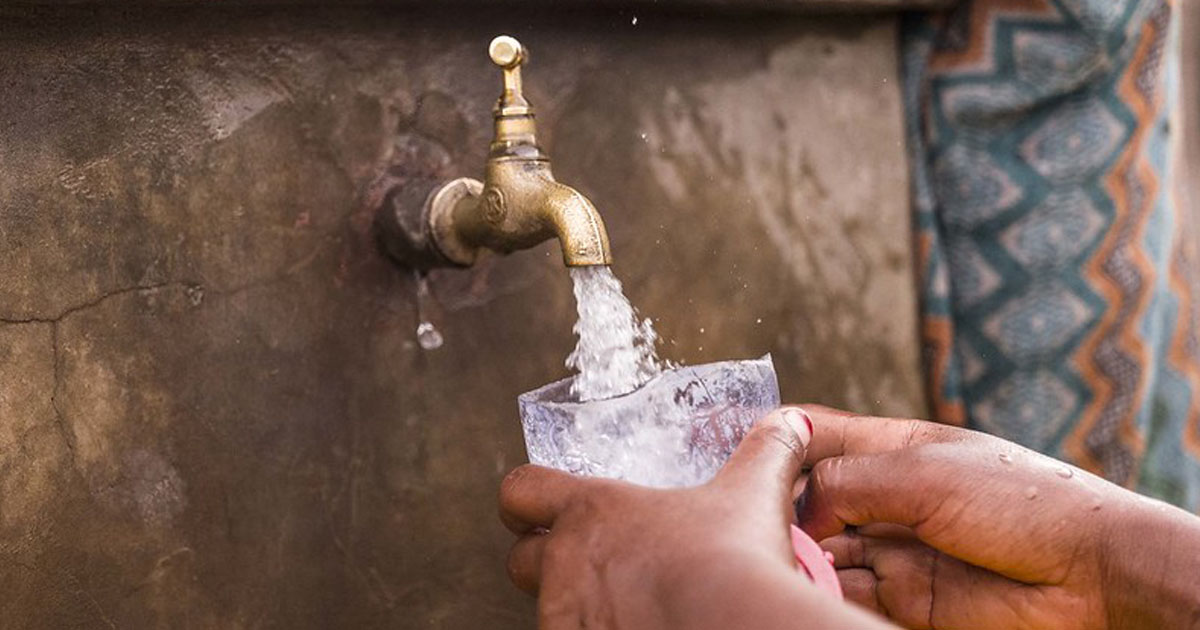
(499, 464, 593, 535)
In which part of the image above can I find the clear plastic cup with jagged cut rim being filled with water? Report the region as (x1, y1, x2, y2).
(517, 354, 779, 487)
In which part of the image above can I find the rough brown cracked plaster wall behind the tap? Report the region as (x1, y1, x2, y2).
(0, 8, 923, 629)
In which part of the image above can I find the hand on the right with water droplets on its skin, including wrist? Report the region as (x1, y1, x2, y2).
(797, 407, 1200, 630)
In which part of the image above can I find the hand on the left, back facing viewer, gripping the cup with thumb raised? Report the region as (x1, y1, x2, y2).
(500, 409, 887, 630)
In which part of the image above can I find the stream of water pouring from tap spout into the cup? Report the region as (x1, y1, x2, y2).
(566, 265, 664, 402)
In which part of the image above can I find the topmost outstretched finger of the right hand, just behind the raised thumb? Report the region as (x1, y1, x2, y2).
(804, 406, 983, 466)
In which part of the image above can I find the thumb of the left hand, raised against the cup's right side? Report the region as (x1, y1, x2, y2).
(715, 407, 812, 500)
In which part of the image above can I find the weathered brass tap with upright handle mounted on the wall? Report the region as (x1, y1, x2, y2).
(382, 35, 612, 266)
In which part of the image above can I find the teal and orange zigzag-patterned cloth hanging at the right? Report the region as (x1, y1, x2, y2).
(902, 0, 1200, 510)
